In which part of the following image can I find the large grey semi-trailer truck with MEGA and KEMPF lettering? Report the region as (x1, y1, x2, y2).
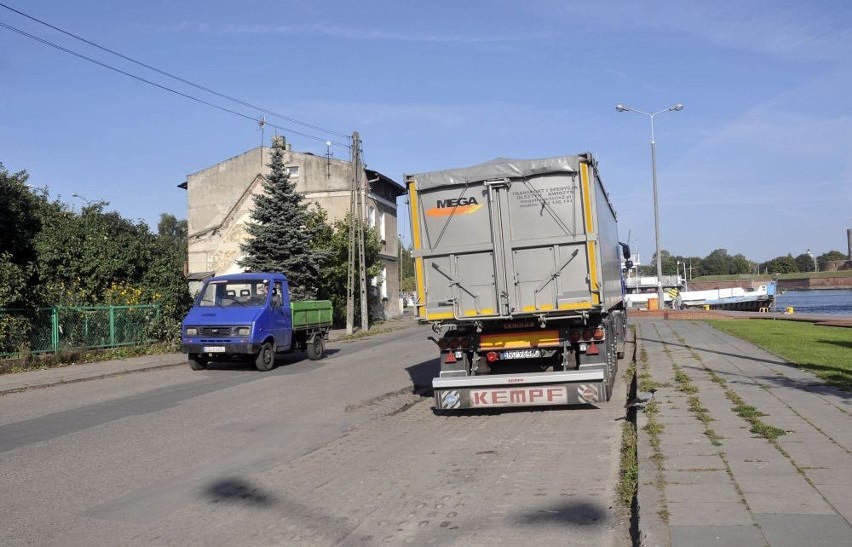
(405, 153, 630, 411)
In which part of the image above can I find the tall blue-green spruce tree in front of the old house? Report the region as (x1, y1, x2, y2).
(239, 141, 324, 299)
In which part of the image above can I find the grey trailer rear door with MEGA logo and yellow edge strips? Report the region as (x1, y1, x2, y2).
(409, 157, 599, 320)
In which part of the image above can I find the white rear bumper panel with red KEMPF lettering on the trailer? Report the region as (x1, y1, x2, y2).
(433, 372, 606, 410)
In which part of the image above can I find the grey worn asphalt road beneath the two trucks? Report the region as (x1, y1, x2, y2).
(0, 327, 630, 546)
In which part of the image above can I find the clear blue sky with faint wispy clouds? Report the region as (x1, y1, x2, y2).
(0, 0, 852, 262)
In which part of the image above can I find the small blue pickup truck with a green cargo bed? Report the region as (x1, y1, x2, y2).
(181, 273, 332, 372)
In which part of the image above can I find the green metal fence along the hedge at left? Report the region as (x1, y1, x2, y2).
(0, 305, 160, 357)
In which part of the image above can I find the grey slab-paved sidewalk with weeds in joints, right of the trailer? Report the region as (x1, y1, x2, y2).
(631, 316, 852, 547)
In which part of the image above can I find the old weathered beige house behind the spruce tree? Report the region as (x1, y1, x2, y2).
(179, 137, 405, 317)
